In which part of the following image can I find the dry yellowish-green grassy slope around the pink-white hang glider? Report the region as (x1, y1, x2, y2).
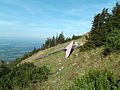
(22, 38, 120, 90)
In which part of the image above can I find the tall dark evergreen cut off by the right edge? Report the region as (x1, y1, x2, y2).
(103, 3, 120, 56)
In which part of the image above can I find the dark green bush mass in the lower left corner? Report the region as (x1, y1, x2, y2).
(0, 63, 50, 90)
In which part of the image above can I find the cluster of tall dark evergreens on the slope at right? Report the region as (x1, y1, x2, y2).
(82, 3, 120, 56)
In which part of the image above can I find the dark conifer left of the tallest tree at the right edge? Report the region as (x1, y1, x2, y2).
(88, 9, 110, 47)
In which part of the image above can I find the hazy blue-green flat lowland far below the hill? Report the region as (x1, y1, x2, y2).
(0, 38, 44, 62)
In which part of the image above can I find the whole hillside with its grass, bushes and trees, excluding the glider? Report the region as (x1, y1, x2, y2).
(0, 3, 120, 90)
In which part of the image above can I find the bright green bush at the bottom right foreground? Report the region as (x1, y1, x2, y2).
(67, 70, 120, 90)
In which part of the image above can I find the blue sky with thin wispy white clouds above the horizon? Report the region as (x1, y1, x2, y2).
(0, 0, 116, 39)
